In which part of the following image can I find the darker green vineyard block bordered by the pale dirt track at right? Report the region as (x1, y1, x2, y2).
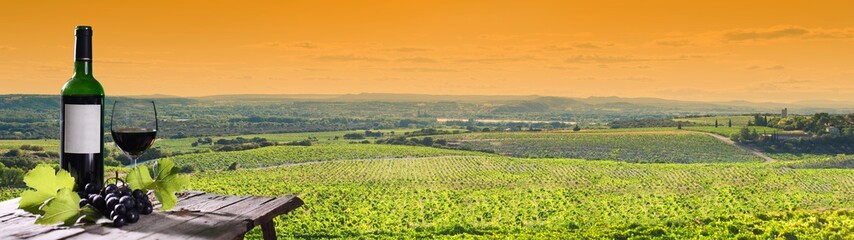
(442, 130, 759, 163)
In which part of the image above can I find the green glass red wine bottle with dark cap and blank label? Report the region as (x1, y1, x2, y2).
(59, 26, 104, 192)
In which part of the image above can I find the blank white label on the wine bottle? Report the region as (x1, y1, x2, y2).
(63, 104, 102, 153)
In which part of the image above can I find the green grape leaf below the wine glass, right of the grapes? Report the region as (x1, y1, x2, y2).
(127, 158, 190, 211)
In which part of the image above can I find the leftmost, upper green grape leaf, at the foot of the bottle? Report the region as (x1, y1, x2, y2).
(18, 164, 74, 214)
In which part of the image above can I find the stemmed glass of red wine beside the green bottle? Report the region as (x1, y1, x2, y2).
(110, 100, 157, 166)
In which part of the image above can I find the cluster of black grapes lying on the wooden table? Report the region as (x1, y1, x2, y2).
(80, 183, 154, 227)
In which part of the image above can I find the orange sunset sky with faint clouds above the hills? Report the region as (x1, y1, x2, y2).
(0, 0, 854, 102)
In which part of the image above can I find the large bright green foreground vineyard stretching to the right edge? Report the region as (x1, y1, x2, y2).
(192, 156, 854, 239)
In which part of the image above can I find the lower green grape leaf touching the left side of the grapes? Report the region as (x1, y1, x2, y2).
(36, 188, 83, 226)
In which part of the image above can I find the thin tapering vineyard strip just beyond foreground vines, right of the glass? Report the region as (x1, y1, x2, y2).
(165, 144, 482, 171)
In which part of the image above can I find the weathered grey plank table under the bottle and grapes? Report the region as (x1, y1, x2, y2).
(0, 192, 303, 240)
